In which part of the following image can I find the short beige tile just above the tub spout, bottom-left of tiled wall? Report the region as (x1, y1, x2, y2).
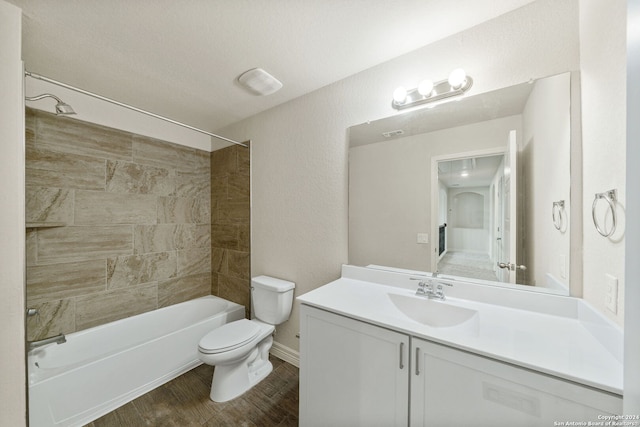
(27, 298, 76, 341)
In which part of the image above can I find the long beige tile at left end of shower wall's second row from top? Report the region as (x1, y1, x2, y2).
(25, 147, 106, 190)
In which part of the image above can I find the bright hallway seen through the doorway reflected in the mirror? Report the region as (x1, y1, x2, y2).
(437, 154, 508, 281)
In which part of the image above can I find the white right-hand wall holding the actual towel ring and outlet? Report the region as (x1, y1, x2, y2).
(580, 0, 626, 325)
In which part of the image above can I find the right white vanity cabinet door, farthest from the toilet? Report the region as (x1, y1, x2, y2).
(411, 338, 622, 427)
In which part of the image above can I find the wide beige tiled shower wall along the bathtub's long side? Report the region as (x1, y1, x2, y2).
(26, 109, 212, 340)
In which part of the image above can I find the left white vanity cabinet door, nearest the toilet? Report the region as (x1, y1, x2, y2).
(299, 305, 409, 427)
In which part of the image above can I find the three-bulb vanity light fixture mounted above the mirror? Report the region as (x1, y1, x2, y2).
(391, 68, 473, 110)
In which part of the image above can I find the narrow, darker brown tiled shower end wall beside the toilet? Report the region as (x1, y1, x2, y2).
(211, 146, 251, 317)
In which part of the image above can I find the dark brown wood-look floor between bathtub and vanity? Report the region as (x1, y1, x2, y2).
(87, 356, 298, 427)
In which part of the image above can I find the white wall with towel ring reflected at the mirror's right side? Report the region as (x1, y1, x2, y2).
(521, 74, 571, 289)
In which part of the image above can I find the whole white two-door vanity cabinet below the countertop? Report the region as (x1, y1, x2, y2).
(300, 304, 622, 427)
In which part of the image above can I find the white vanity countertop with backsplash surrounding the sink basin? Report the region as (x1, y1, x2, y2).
(298, 266, 623, 395)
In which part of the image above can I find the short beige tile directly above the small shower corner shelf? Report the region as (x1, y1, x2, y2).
(25, 187, 73, 224)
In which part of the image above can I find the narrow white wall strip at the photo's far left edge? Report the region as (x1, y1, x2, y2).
(0, 0, 26, 427)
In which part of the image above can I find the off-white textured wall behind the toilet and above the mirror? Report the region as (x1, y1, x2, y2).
(222, 0, 579, 349)
